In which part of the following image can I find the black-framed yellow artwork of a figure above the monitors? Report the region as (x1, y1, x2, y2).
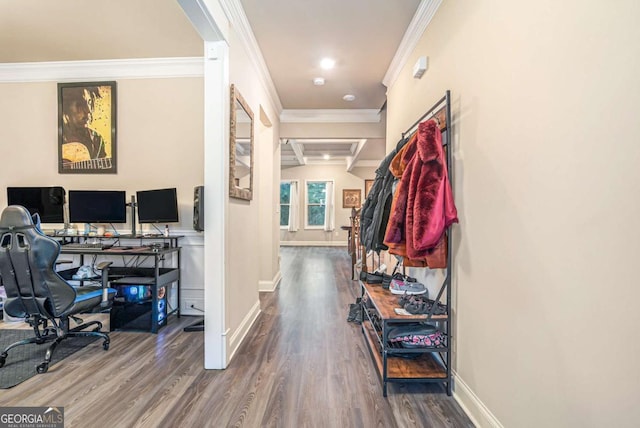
(58, 82, 117, 174)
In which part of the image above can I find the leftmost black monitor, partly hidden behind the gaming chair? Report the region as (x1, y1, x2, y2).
(7, 186, 66, 223)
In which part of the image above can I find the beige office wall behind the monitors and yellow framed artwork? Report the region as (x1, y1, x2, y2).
(0, 77, 203, 314)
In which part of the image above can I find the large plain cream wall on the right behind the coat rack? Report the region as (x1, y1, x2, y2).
(387, 0, 640, 427)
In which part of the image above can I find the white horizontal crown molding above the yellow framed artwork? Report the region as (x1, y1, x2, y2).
(0, 57, 204, 83)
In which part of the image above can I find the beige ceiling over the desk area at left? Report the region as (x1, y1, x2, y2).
(0, 0, 202, 63)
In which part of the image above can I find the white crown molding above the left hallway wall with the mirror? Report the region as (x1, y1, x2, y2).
(220, 0, 282, 114)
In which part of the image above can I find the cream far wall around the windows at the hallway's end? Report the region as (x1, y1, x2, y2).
(280, 165, 375, 245)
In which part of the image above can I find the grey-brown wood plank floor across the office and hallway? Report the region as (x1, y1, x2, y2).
(0, 247, 473, 427)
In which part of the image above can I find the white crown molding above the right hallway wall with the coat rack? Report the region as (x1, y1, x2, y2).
(382, 0, 442, 88)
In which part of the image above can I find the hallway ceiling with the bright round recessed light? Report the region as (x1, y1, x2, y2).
(240, 0, 420, 109)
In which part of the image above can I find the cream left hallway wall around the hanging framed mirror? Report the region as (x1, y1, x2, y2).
(225, 23, 279, 357)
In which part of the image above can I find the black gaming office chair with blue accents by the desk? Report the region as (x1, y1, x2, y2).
(0, 205, 116, 373)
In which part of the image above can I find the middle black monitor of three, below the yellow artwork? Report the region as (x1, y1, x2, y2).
(69, 190, 127, 223)
